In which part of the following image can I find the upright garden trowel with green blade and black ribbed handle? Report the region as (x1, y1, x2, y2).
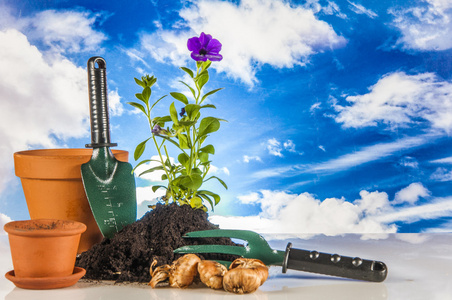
(82, 56, 137, 238)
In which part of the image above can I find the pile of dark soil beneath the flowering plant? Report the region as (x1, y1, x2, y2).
(76, 204, 240, 282)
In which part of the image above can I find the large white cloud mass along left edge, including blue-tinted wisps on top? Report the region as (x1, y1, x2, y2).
(0, 6, 106, 197)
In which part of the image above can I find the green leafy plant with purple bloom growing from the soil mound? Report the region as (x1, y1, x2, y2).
(129, 33, 227, 211)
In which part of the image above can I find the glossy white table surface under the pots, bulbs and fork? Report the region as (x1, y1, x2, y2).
(0, 233, 452, 300)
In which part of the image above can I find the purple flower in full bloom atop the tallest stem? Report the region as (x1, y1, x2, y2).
(187, 32, 223, 61)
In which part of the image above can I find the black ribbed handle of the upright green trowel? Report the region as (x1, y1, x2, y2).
(86, 56, 117, 148)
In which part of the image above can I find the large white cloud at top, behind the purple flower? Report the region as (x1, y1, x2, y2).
(141, 0, 345, 86)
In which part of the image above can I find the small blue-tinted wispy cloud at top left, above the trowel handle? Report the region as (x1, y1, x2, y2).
(21, 10, 107, 53)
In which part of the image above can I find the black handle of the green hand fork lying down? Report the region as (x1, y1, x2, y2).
(282, 243, 388, 282)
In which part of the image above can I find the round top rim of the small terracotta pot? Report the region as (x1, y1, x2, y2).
(3, 219, 87, 237)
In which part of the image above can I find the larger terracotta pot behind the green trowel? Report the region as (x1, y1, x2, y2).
(14, 149, 129, 253)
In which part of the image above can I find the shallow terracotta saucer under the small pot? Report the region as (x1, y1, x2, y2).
(5, 267, 86, 290)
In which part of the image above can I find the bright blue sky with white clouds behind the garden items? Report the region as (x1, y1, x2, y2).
(0, 0, 452, 234)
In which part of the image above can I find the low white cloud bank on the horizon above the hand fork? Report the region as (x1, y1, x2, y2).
(210, 190, 396, 235)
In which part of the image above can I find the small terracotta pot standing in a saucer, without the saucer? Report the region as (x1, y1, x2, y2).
(4, 219, 86, 278)
